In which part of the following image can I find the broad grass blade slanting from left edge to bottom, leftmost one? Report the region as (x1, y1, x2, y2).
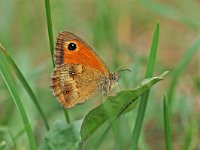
(0, 51, 37, 150)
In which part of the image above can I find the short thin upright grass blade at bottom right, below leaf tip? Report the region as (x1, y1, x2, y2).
(163, 94, 172, 150)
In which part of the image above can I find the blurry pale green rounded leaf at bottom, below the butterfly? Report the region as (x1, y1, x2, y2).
(39, 121, 80, 150)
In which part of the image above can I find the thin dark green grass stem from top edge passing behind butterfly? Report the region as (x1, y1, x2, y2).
(45, 0, 70, 123)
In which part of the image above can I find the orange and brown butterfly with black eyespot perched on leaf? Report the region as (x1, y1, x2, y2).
(50, 31, 120, 108)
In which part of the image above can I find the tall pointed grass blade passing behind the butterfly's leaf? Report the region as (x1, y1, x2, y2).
(130, 22, 160, 149)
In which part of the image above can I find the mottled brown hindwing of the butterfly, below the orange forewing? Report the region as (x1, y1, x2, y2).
(51, 64, 104, 108)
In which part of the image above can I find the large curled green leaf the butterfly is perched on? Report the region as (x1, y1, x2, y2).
(81, 72, 167, 144)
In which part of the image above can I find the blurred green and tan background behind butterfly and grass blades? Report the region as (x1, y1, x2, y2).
(0, 0, 200, 150)
